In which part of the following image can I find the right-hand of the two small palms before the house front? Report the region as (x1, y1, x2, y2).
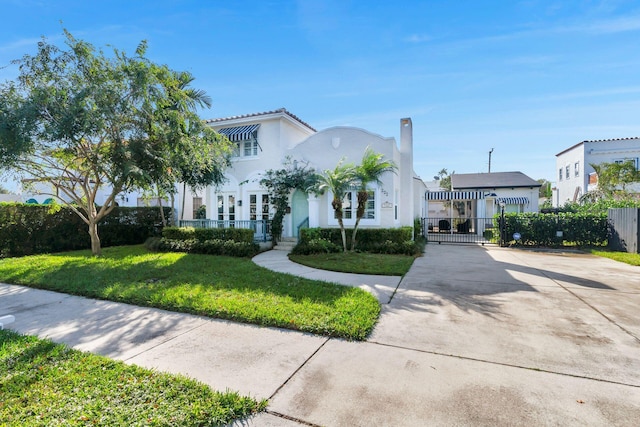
(351, 147, 398, 250)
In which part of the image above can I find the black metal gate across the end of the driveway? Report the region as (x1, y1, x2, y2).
(421, 218, 500, 245)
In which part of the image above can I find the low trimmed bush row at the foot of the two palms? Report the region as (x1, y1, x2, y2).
(291, 227, 423, 255)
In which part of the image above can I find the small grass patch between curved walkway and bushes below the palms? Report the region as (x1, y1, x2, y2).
(289, 252, 415, 276)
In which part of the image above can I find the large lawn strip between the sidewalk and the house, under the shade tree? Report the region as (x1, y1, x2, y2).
(0, 246, 380, 340)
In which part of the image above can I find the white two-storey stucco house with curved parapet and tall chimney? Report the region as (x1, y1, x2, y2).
(189, 108, 426, 237)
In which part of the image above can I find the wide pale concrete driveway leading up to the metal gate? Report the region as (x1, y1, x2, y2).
(270, 244, 640, 426)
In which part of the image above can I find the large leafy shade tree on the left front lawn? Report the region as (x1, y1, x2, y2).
(0, 31, 232, 255)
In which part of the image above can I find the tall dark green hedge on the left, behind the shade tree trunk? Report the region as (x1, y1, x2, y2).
(0, 203, 171, 258)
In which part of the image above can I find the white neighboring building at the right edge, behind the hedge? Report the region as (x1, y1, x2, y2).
(553, 138, 640, 207)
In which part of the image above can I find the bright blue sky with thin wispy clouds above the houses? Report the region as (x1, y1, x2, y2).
(0, 0, 640, 191)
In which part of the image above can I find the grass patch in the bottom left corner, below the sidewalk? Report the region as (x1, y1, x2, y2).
(0, 330, 266, 426)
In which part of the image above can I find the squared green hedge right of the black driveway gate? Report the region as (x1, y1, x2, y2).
(498, 212, 609, 247)
